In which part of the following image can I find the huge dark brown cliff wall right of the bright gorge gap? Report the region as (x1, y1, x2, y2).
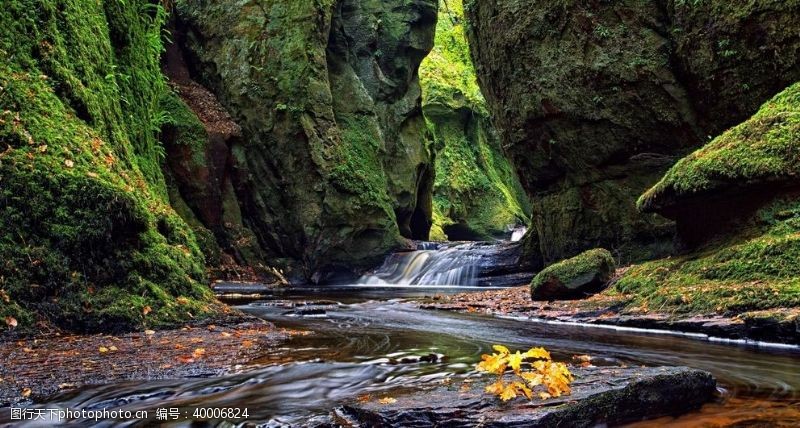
(466, 0, 800, 262)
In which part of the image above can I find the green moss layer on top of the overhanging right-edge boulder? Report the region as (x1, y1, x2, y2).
(638, 83, 800, 209)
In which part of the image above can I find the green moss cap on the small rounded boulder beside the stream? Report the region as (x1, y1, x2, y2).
(531, 248, 616, 290)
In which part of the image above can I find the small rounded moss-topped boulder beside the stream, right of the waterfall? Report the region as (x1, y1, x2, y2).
(531, 248, 617, 300)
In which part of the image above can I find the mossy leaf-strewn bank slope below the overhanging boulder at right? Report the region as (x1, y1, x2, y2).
(616, 199, 800, 313)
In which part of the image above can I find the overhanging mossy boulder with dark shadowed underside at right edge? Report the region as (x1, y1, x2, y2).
(639, 84, 800, 245)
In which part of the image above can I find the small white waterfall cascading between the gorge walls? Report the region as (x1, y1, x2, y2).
(359, 242, 481, 287)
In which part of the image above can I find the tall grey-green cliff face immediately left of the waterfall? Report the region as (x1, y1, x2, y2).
(176, 0, 437, 281)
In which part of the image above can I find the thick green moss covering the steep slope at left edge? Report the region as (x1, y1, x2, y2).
(0, 0, 213, 332)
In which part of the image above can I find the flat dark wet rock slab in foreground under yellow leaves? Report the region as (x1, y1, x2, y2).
(334, 367, 716, 427)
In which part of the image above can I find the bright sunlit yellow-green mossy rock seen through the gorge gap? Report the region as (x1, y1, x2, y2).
(420, 0, 530, 240)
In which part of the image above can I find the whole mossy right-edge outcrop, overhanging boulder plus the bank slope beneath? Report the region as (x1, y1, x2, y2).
(616, 84, 800, 314)
